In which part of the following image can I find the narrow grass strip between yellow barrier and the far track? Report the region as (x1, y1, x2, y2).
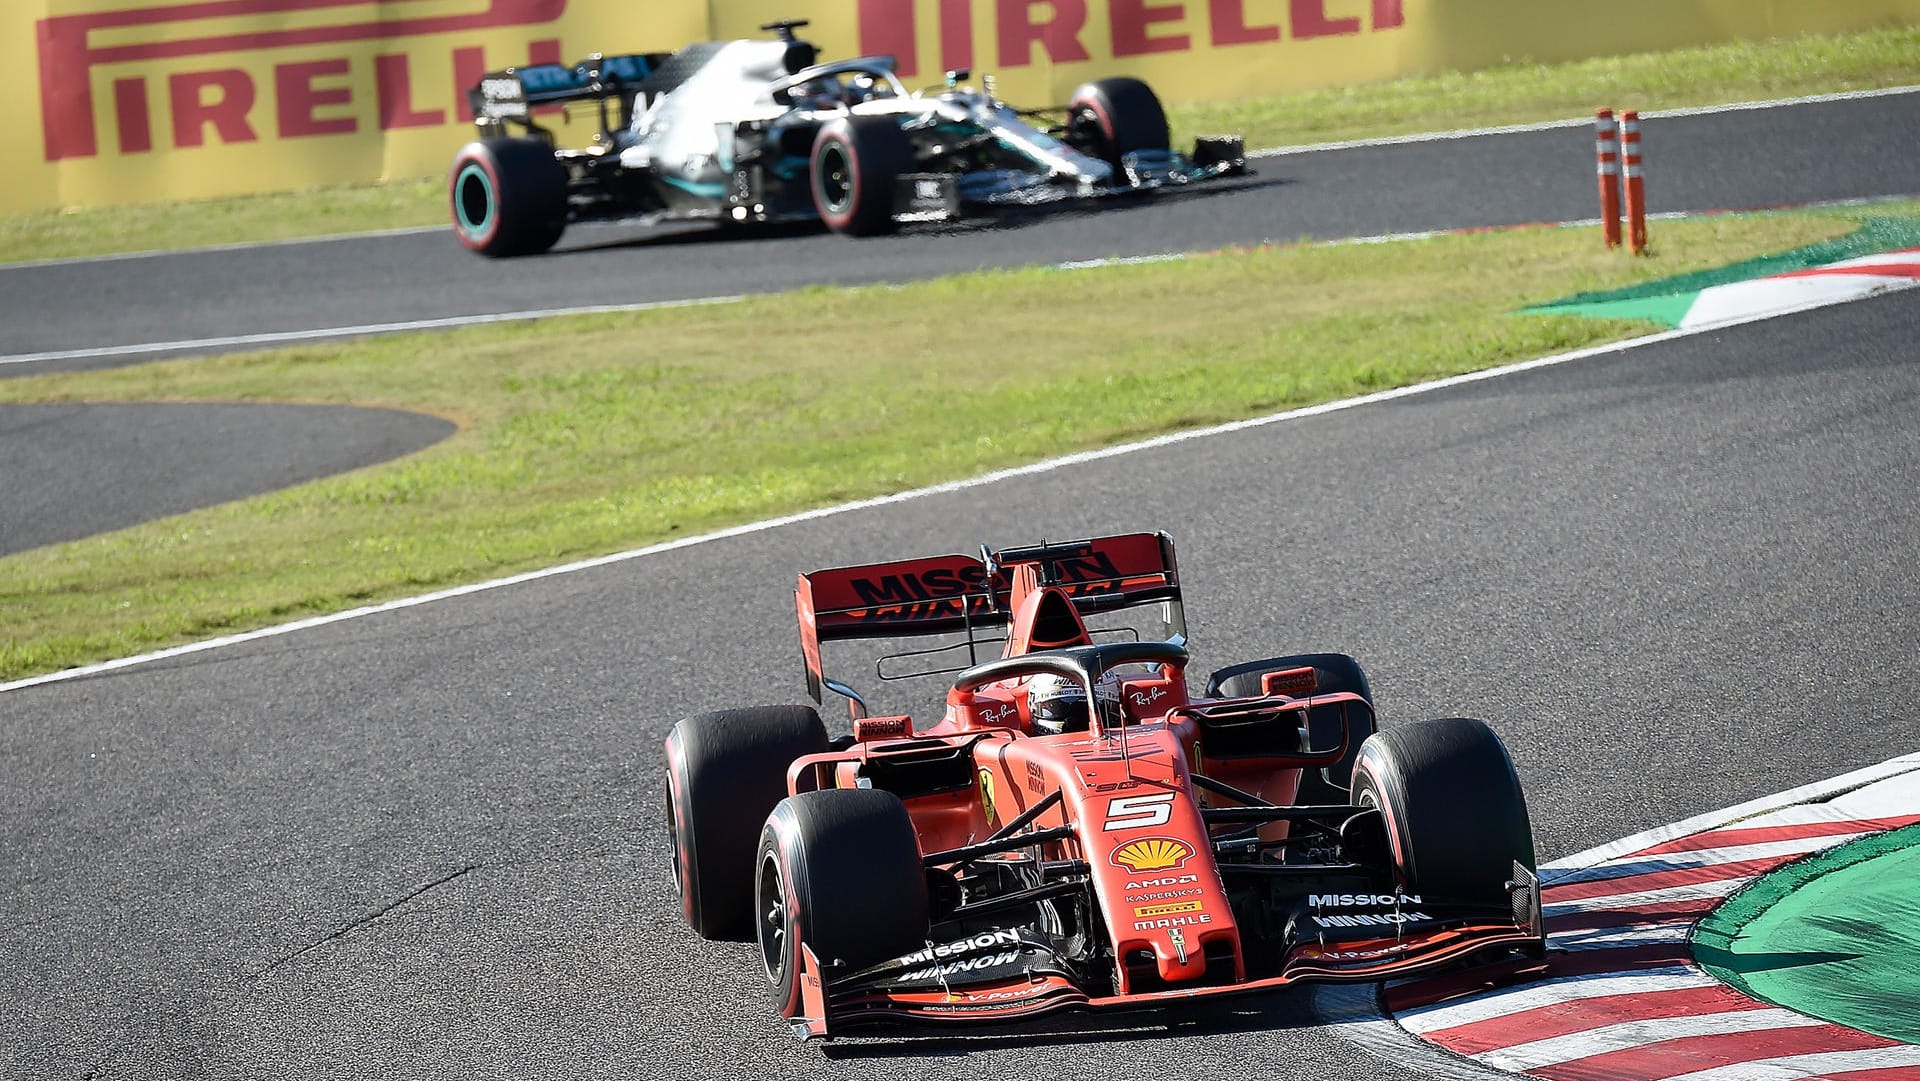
(0, 27, 1920, 263)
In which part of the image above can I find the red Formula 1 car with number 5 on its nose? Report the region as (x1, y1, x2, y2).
(666, 534, 1546, 1037)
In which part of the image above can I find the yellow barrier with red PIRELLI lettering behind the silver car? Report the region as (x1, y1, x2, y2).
(0, 0, 1920, 213)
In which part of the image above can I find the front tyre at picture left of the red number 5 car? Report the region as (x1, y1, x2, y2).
(753, 789, 927, 1018)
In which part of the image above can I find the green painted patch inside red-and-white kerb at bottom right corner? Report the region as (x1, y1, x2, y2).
(1690, 824, 1920, 1045)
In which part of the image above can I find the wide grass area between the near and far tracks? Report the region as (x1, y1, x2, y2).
(0, 204, 1920, 680)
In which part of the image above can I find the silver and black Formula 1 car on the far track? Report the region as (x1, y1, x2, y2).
(447, 21, 1246, 255)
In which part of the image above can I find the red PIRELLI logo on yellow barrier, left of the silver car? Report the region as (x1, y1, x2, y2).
(35, 0, 566, 161)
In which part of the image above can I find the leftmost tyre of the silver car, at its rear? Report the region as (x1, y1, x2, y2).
(447, 138, 566, 257)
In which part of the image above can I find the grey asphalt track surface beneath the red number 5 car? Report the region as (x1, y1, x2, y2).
(0, 292, 1920, 1081)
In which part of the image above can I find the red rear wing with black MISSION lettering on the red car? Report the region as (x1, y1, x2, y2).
(793, 532, 1187, 701)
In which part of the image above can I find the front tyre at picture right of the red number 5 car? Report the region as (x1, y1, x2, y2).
(1354, 716, 1536, 908)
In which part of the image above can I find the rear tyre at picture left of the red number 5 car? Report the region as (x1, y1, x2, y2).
(666, 707, 828, 939)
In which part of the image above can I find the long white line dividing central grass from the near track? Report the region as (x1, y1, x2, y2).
(0, 278, 1920, 698)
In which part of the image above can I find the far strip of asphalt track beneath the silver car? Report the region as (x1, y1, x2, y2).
(0, 92, 1920, 374)
